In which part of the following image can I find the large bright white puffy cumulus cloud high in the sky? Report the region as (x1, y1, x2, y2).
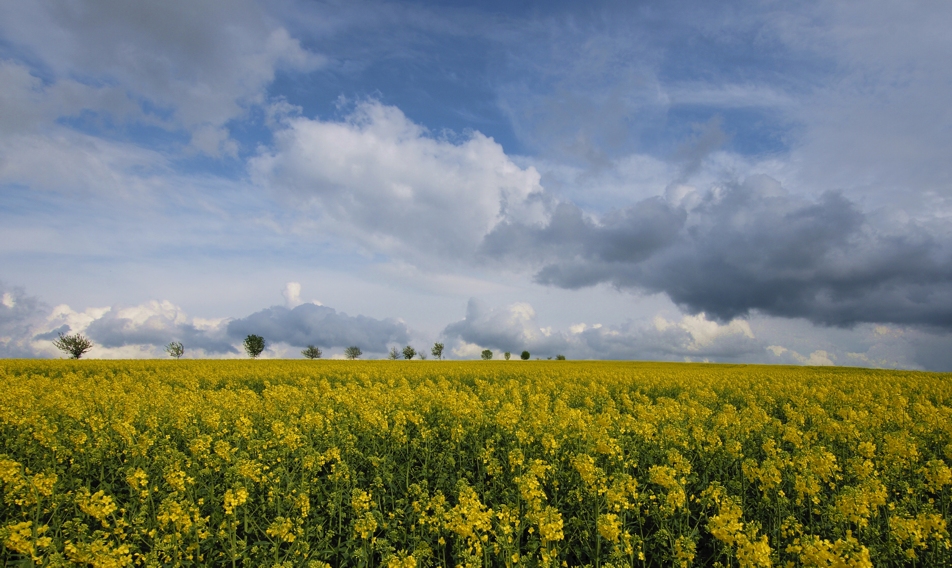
(250, 101, 542, 262)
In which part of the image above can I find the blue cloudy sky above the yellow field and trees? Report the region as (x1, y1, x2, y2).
(0, 0, 952, 371)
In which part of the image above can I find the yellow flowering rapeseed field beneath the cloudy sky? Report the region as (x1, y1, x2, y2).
(0, 360, 952, 568)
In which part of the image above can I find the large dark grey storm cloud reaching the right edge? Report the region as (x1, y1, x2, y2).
(481, 176, 952, 330)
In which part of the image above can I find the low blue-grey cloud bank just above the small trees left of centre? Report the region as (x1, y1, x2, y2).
(228, 304, 410, 353)
